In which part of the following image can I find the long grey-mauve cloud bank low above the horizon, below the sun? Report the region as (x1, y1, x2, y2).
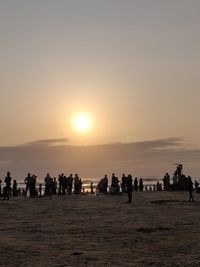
(0, 138, 200, 180)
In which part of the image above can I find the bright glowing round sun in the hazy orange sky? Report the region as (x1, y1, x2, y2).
(72, 113, 92, 133)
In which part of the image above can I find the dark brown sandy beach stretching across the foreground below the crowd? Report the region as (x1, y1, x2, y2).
(0, 192, 200, 267)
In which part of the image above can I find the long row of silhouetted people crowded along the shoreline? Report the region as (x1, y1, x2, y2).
(0, 165, 200, 202)
